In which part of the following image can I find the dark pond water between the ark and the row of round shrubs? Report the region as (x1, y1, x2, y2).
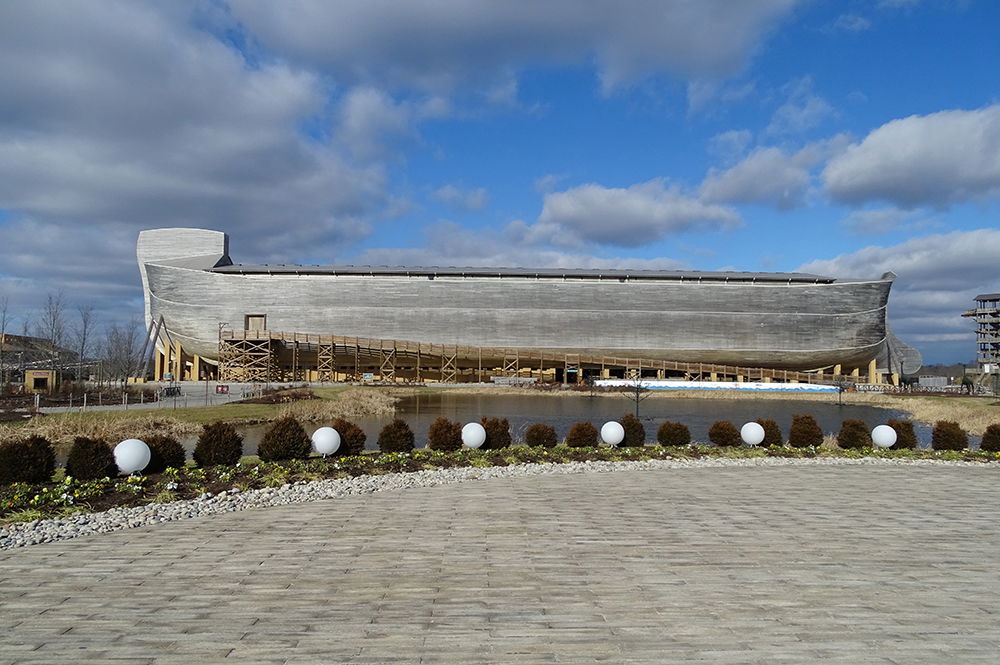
(184, 391, 930, 455)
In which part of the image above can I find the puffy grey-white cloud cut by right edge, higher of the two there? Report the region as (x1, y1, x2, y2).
(823, 105, 1000, 208)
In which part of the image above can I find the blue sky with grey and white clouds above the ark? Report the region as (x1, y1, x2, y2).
(0, 0, 1000, 362)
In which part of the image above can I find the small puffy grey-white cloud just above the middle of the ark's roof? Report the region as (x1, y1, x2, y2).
(510, 179, 742, 247)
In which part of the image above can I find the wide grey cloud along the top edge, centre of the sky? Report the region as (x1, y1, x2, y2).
(229, 0, 797, 91)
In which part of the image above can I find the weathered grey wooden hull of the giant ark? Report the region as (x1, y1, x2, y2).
(138, 229, 908, 371)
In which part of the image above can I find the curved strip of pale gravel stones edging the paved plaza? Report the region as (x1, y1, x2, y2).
(0, 457, 1000, 549)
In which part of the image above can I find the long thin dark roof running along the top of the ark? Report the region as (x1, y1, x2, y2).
(209, 264, 836, 284)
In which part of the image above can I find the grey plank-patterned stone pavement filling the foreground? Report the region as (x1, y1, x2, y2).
(0, 466, 1000, 665)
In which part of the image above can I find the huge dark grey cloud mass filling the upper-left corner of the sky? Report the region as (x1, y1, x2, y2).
(0, 0, 394, 254)
